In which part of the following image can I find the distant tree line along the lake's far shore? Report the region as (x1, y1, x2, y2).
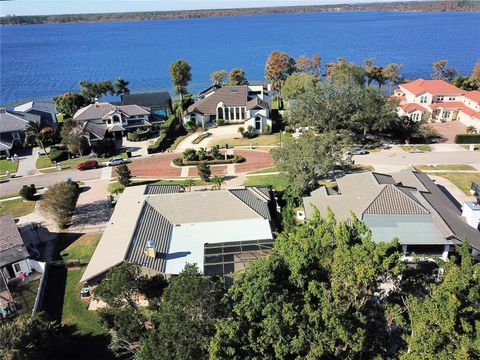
(0, 0, 480, 25)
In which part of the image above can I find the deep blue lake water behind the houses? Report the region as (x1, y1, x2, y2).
(0, 12, 480, 104)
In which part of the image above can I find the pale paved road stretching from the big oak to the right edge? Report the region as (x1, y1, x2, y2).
(353, 149, 480, 166)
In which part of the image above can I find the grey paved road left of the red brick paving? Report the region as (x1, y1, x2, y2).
(0, 168, 102, 195)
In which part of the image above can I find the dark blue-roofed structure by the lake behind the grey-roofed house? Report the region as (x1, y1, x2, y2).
(122, 91, 172, 121)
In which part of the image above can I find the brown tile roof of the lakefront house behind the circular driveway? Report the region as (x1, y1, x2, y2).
(187, 85, 248, 115)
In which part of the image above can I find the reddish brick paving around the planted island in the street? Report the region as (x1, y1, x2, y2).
(128, 149, 273, 177)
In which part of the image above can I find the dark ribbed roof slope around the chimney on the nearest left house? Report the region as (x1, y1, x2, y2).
(126, 202, 173, 272)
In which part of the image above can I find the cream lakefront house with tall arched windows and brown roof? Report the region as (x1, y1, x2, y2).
(183, 85, 272, 133)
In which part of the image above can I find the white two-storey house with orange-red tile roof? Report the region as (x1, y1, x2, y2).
(392, 78, 480, 129)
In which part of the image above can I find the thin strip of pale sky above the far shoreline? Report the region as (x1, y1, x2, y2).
(0, 0, 402, 15)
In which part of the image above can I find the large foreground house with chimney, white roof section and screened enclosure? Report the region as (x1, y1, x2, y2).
(81, 185, 276, 285)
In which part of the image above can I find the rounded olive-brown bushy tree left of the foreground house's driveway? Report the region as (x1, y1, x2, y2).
(40, 181, 80, 228)
